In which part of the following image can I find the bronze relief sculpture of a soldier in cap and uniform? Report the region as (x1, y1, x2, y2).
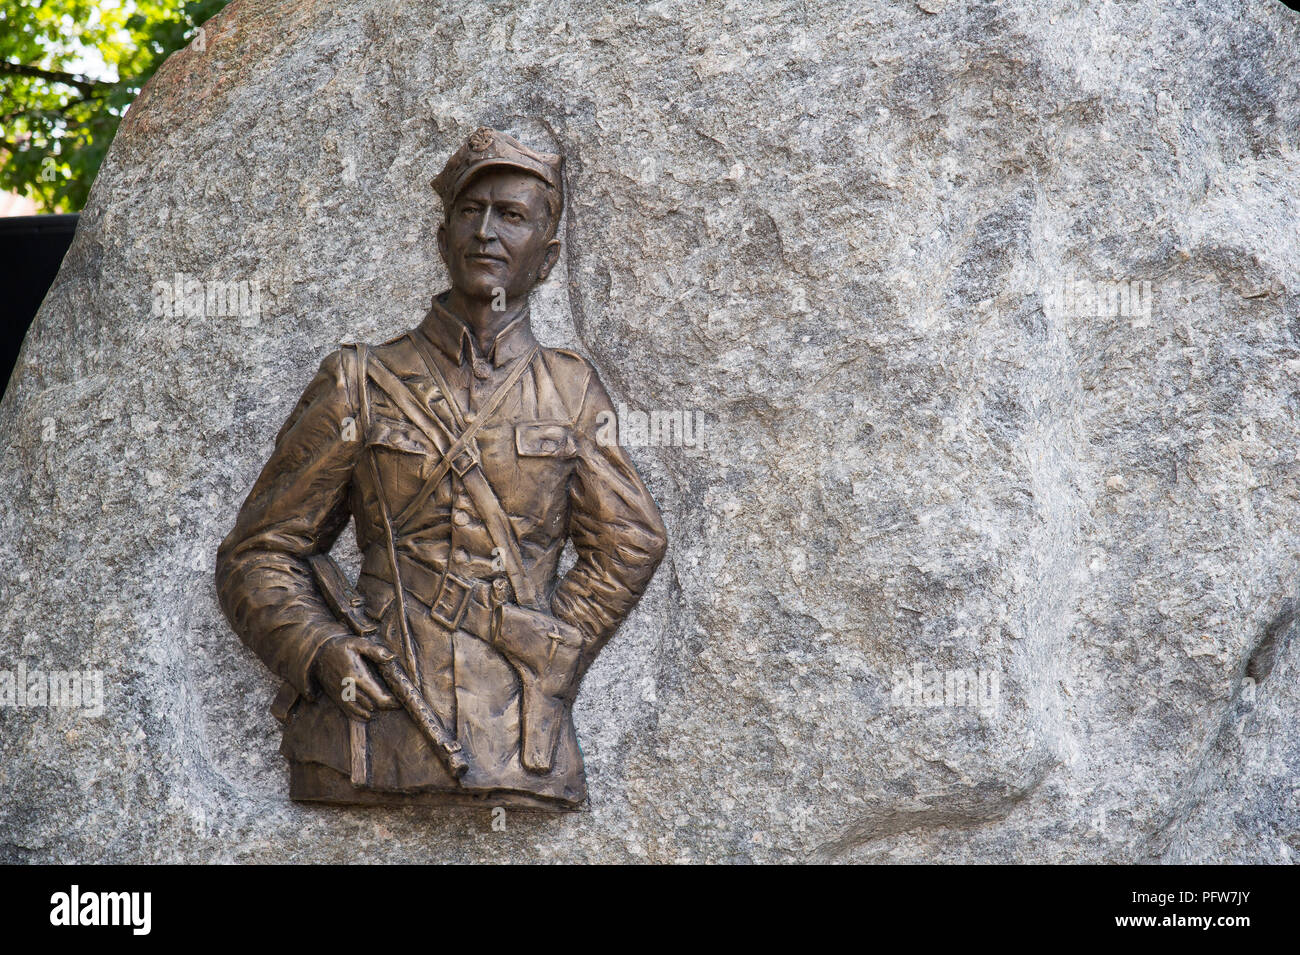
(216, 129, 667, 809)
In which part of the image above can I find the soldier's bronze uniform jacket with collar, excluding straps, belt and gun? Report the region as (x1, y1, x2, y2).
(216, 294, 667, 806)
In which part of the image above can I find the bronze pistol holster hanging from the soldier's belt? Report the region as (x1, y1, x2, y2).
(489, 604, 582, 773)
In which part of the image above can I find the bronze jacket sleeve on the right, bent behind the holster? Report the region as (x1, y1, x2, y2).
(551, 370, 668, 669)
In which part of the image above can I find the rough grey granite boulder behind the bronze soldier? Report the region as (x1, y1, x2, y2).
(0, 0, 1300, 863)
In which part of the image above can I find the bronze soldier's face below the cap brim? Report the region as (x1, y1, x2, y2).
(438, 169, 560, 300)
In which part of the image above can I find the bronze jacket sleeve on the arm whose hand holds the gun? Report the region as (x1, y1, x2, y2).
(216, 350, 363, 699)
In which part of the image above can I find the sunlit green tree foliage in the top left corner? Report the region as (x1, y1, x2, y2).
(0, 0, 229, 212)
